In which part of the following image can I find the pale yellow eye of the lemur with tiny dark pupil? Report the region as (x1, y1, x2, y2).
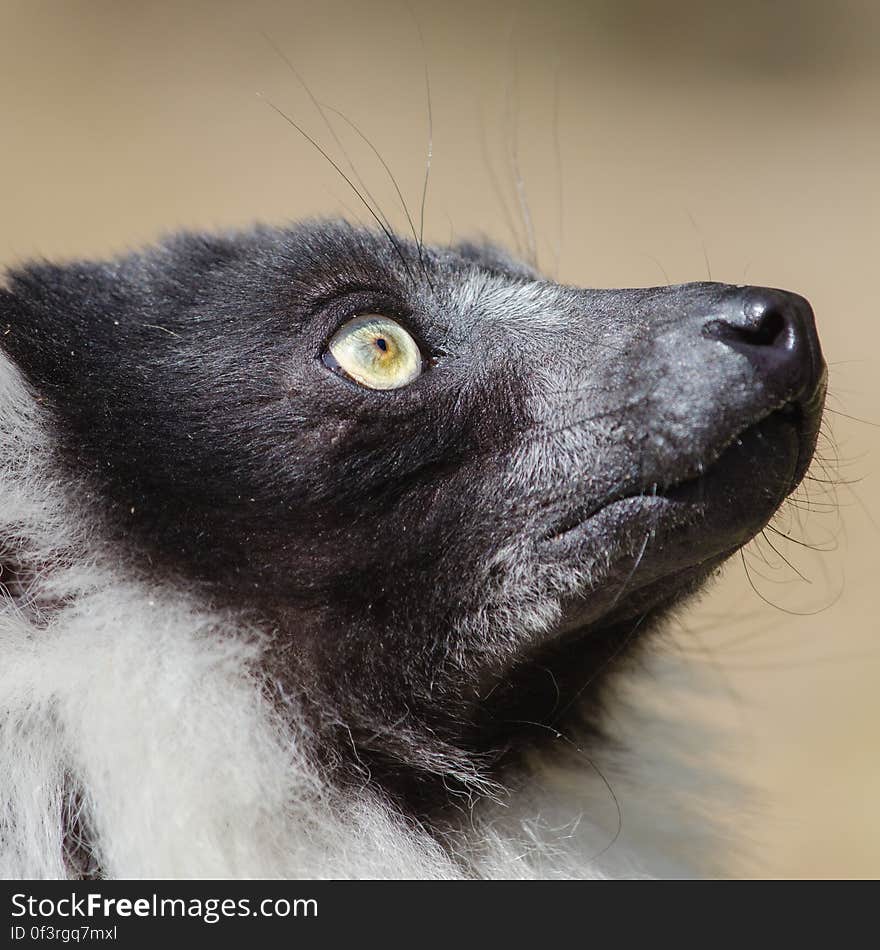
(329, 313, 422, 389)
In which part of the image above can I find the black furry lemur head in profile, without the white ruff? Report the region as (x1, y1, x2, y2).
(0, 223, 825, 809)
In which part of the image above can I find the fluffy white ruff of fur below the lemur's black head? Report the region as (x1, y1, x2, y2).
(0, 357, 736, 878)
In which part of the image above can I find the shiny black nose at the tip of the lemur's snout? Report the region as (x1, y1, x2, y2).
(703, 287, 824, 400)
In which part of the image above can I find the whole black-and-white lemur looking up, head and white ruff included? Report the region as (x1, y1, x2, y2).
(0, 222, 825, 878)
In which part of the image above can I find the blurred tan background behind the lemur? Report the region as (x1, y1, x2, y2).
(0, 0, 880, 877)
